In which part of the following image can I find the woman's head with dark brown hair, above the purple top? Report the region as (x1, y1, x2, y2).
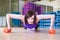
(25, 10, 36, 24)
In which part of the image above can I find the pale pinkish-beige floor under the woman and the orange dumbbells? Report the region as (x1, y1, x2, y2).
(0, 27, 60, 40)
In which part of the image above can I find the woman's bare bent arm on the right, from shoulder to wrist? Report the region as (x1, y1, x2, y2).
(37, 14, 55, 29)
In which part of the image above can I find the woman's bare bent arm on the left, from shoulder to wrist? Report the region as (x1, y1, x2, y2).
(6, 14, 24, 29)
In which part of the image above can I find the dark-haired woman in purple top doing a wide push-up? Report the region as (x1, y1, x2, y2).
(6, 10, 55, 30)
